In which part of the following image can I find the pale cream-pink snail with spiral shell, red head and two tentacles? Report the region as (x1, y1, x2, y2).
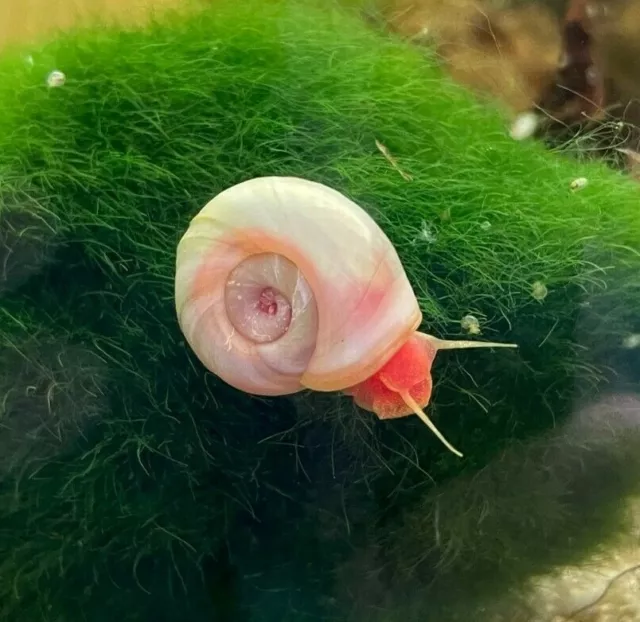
(175, 177, 517, 456)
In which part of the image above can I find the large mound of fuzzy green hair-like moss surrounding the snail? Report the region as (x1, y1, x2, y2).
(0, 0, 640, 622)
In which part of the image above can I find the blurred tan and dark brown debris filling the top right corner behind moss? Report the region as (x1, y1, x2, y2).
(381, 0, 640, 176)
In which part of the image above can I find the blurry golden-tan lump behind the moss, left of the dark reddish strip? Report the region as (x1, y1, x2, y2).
(382, 0, 562, 112)
